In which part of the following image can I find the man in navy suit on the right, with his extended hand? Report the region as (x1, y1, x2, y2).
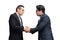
(25, 5, 54, 40)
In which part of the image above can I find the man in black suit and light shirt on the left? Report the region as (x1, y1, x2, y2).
(9, 5, 24, 40)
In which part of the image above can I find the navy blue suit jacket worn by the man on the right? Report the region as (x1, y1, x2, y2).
(30, 14, 53, 40)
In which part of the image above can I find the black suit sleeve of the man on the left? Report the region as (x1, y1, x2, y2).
(9, 16, 24, 31)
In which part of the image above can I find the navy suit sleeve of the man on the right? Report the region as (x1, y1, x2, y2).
(30, 17, 49, 34)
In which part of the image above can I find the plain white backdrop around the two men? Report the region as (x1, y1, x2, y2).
(0, 0, 60, 40)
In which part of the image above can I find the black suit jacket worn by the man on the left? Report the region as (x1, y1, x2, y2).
(9, 13, 24, 40)
